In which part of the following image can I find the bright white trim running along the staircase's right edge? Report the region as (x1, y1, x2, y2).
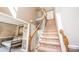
(55, 12, 66, 52)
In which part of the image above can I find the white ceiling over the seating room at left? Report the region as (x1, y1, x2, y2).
(0, 12, 25, 25)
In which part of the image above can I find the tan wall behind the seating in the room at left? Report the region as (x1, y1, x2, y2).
(0, 23, 16, 37)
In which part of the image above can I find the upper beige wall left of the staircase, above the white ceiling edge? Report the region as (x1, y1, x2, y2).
(16, 7, 38, 22)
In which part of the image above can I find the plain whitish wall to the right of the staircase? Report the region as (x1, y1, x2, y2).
(56, 7, 79, 45)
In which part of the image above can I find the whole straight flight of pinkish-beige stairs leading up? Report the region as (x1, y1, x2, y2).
(36, 19, 61, 52)
